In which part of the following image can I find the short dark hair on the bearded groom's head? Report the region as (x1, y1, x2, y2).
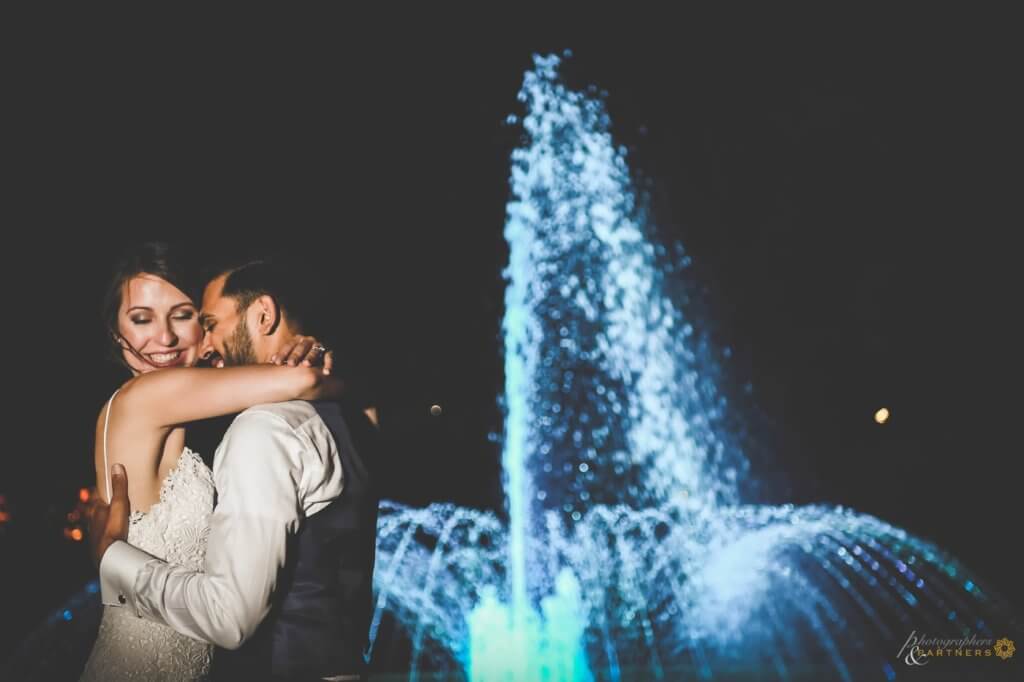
(214, 259, 315, 334)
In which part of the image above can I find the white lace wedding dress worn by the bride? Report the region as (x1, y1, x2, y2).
(82, 447, 214, 681)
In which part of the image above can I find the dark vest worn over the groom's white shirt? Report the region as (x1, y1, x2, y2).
(212, 402, 379, 680)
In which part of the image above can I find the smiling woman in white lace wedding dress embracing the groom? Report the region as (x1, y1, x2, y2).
(81, 244, 340, 681)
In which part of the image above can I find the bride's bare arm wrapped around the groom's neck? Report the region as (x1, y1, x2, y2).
(115, 365, 343, 428)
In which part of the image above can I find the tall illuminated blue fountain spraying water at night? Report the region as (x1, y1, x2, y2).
(366, 56, 1017, 681)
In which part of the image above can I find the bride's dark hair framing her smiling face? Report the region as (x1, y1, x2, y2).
(100, 242, 200, 371)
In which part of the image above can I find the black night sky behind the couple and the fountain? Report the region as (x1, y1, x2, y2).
(0, 9, 1024, 671)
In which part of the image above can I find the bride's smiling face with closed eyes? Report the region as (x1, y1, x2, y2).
(118, 274, 203, 374)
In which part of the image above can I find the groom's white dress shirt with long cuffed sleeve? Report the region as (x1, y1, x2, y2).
(99, 400, 350, 649)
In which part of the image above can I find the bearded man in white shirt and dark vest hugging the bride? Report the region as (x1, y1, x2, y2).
(90, 256, 378, 680)
